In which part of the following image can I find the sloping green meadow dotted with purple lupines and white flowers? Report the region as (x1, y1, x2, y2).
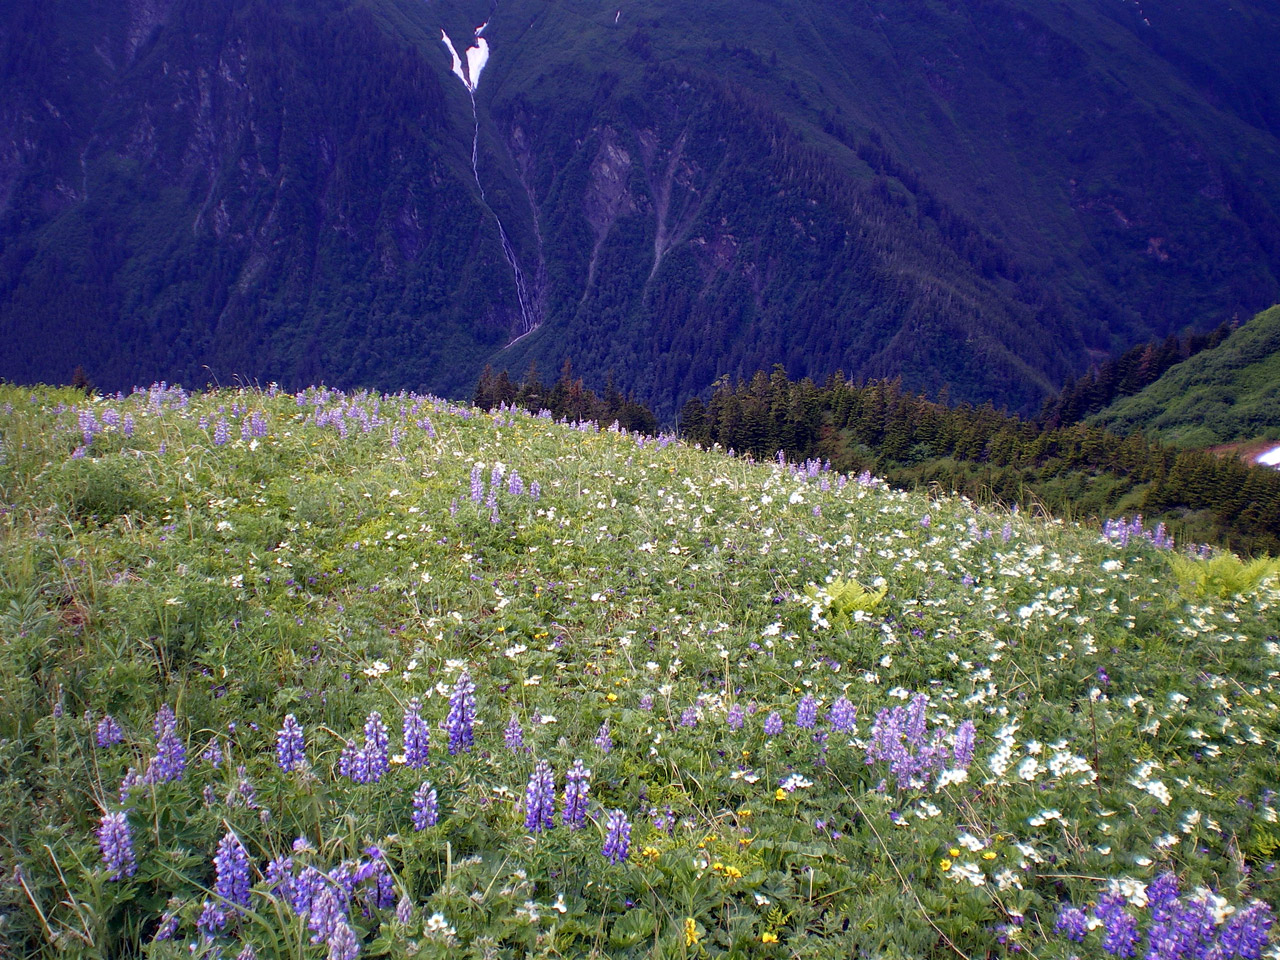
(0, 384, 1280, 960)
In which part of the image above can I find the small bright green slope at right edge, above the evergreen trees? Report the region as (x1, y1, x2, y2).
(1089, 306, 1280, 447)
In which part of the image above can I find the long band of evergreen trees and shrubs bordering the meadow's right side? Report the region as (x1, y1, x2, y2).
(681, 366, 1280, 553)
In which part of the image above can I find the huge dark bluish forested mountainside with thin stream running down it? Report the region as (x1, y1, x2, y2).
(0, 0, 1280, 416)
